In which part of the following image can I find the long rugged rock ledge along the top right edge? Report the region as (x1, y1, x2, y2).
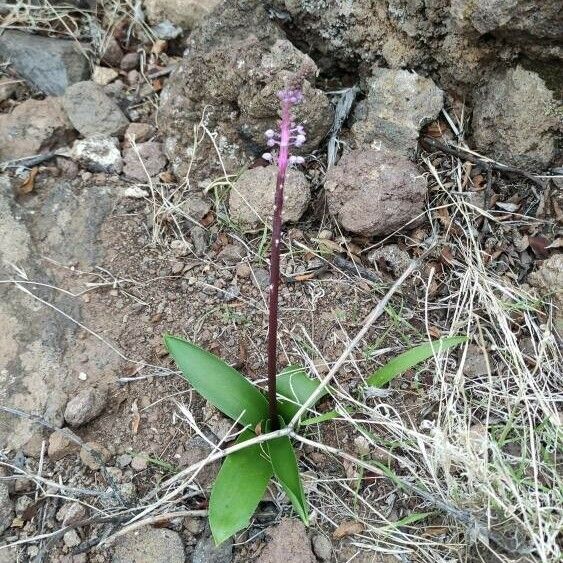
(271, 0, 563, 95)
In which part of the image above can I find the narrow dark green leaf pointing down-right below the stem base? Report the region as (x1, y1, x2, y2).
(265, 416, 309, 525)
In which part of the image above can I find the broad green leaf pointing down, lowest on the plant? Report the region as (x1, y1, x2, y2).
(209, 430, 273, 545)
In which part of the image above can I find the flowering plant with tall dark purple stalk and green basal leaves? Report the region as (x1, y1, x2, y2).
(165, 84, 323, 544)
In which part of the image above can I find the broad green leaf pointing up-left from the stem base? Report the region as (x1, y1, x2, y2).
(164, 336, 268, 429)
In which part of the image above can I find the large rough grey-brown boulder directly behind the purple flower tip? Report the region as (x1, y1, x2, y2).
(159, 1, 333, 176)
